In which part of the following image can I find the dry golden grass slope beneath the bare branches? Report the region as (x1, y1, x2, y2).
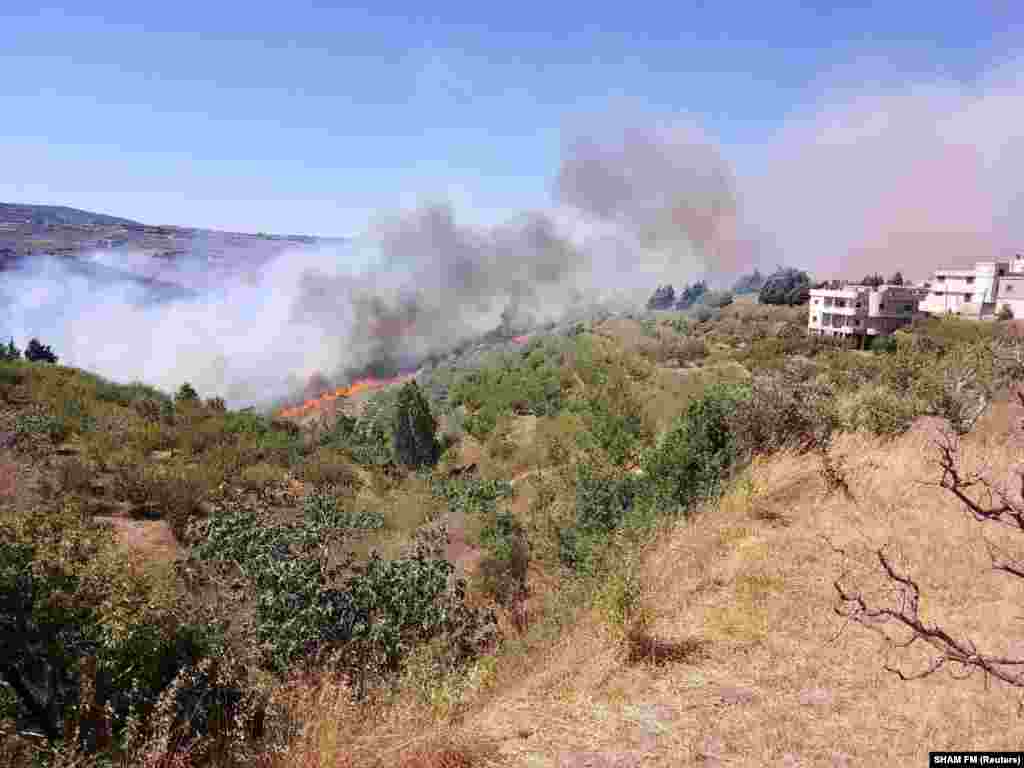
(436, 403, 1024, 766)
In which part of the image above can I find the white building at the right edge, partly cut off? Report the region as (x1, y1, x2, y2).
(921, 259, 1024, 317)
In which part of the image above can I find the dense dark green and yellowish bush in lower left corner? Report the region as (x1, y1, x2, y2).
(0, 506, 218, 739)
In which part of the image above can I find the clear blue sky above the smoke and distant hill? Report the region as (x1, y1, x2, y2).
(0, 0, 1024, 234)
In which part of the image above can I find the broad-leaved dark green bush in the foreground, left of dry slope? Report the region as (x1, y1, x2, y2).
(197, 512, 494, 686)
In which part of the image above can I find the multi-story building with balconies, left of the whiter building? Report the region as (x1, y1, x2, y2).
(807, 286, 921, 343)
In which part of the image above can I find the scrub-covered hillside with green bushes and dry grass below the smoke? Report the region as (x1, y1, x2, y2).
(0, 292, 1024, 768)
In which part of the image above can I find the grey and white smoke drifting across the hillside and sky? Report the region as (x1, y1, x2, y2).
(0, 58, 1024, 406)
